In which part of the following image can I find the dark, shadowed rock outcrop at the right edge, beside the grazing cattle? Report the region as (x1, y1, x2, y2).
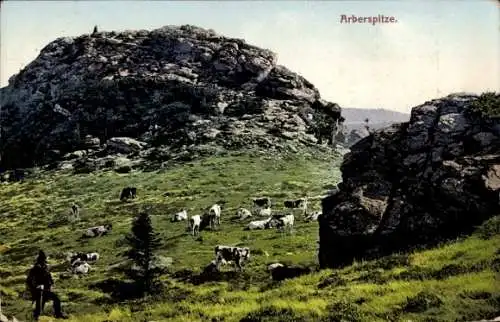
(319, 94, 500, 267)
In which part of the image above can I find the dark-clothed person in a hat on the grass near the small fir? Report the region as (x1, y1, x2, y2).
(26, 250, 67, 321)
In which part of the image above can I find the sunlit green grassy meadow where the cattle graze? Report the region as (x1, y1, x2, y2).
(0, 152, 500, 322)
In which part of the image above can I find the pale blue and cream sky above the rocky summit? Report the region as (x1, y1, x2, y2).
(0, 0, 500, 112)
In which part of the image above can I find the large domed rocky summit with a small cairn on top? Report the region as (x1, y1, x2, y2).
(0, 25, 341, 168)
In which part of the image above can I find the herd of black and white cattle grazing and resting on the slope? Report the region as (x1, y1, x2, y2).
(60, 187, 321, 274)
